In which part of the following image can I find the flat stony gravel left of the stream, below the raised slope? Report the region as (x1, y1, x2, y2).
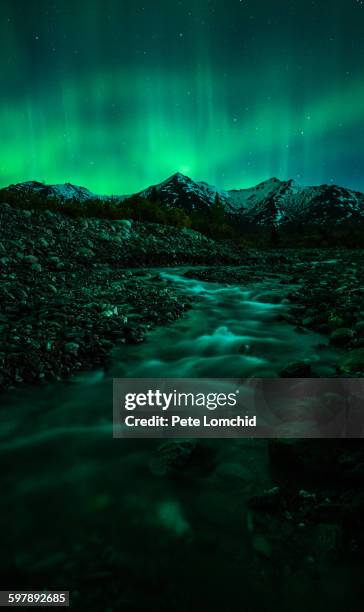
(0, 266, 190, 389)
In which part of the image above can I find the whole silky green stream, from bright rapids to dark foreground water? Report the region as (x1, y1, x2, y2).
(0, 269, 350, 609)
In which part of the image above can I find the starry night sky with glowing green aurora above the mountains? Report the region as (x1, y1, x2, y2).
(0, 0, 364, 194)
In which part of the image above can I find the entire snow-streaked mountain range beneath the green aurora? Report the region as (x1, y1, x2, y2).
(2, 172, 364, 227)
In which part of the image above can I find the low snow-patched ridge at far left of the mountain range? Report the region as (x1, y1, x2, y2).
(0, 181, 122, 203)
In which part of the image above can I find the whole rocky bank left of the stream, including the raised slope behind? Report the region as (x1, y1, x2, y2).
(0, 204, 242, 389)
